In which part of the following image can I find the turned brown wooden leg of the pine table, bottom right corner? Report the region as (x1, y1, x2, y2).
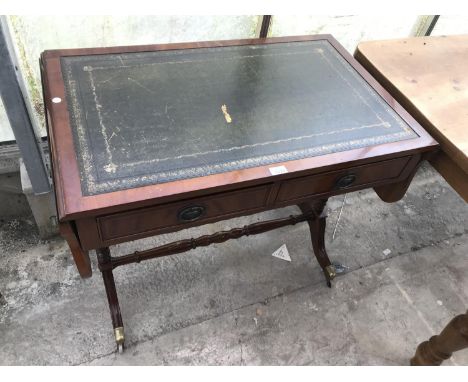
(410, 311, 468, 366)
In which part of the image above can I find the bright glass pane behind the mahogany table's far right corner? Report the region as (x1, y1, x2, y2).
(270, 15, 417, 53)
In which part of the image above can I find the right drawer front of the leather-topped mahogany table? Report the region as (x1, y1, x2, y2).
(276, 157, 411, 203)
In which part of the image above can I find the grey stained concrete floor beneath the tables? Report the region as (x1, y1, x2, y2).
(0, 166, 468, 365)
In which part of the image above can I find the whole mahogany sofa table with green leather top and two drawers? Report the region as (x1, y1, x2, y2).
(41, 35, 438, 350)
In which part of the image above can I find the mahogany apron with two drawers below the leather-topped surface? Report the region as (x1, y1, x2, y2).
(75, 154, 421, 250)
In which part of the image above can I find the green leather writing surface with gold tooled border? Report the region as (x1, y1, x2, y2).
(61, 40, 417, 195)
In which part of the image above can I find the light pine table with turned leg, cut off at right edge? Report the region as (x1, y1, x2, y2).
(355, 35, 468, 365)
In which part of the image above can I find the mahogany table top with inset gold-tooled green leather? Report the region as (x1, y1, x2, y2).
(41, 35, 437, 221)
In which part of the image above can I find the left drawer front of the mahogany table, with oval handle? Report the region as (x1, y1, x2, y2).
(97, 185, 270, 242)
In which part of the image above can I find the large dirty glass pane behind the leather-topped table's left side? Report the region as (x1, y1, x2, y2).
(8, 16, 260, 136)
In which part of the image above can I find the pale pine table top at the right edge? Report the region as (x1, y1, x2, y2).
(355, 35, 468, 176)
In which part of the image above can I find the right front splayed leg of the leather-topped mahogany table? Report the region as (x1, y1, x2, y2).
(298, 199, 336, 288)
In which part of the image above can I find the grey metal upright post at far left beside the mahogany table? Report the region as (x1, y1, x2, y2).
(0, 16, 51, 195)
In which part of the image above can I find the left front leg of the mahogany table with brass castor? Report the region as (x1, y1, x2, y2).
(96, 247, 125, 353)
